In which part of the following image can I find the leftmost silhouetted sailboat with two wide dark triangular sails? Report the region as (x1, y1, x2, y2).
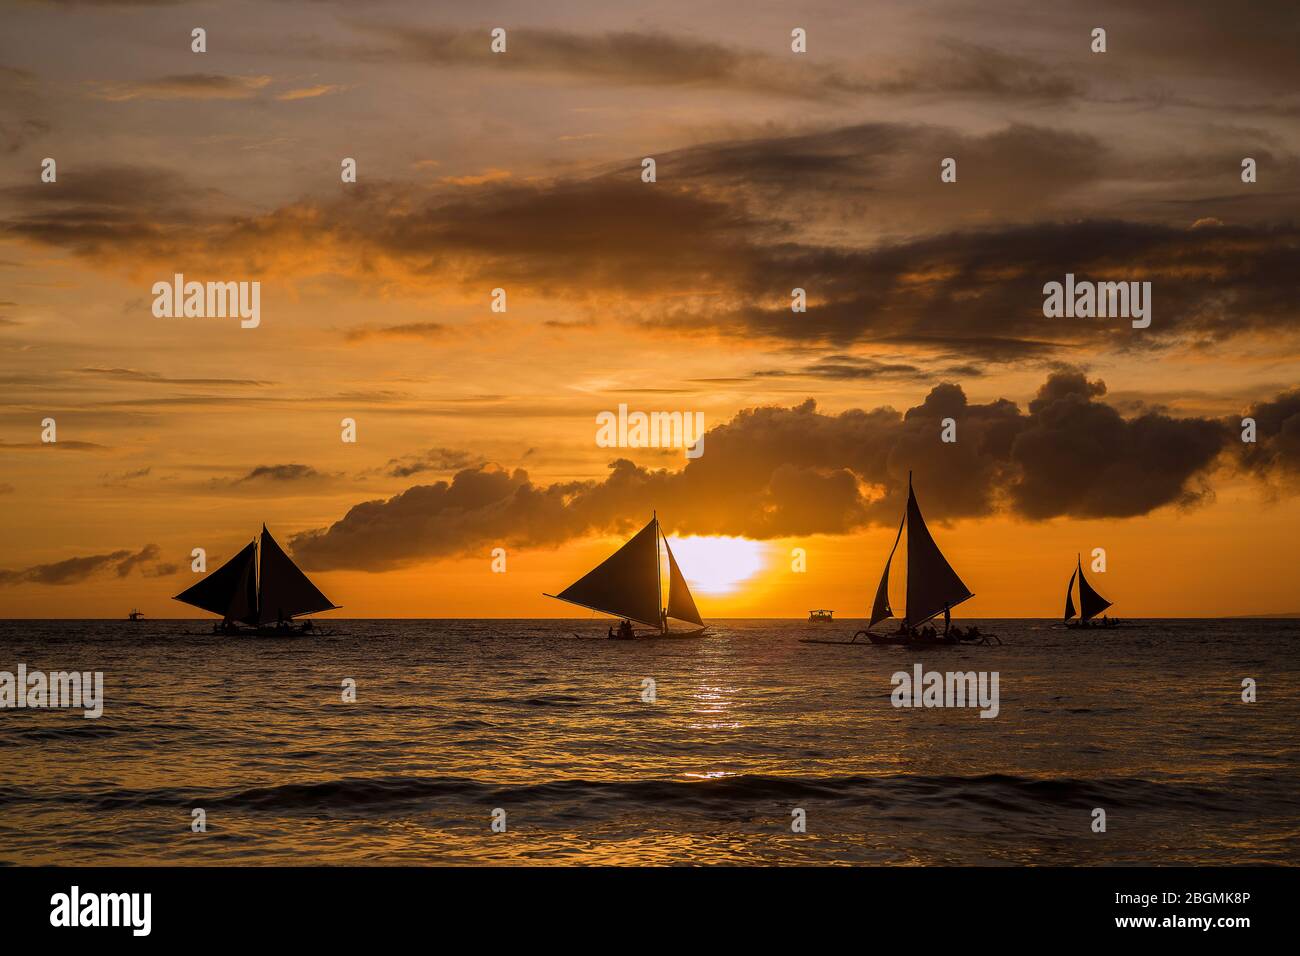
(172, 524, 338, 637)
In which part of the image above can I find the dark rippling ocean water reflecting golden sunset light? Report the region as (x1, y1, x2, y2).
(0, 620, 1300, 865)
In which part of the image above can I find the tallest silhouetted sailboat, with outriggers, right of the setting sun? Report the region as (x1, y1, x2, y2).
(803, 472, 996, 644)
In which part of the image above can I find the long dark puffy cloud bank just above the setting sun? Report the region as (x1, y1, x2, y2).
(293, 371, 1258, 571)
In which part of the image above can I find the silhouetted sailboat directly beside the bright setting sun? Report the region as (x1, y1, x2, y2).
(545, 515, 707, 640)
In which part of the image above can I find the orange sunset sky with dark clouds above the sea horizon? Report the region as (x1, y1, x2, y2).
(0, 0, 1300, 619)
